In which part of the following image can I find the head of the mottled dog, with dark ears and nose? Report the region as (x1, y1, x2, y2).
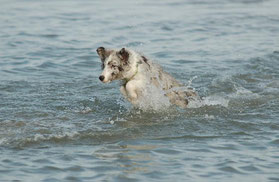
(97, 47, 129, 83)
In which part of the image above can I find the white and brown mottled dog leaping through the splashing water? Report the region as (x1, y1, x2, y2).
(96, 47, 198, 108)
